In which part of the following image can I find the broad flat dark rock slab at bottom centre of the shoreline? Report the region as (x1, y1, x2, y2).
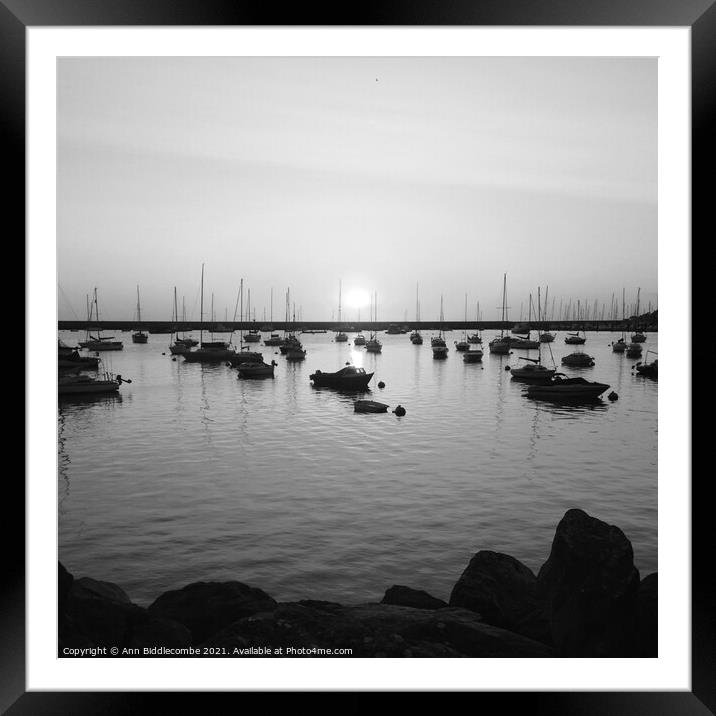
(201, 603, 554, 658)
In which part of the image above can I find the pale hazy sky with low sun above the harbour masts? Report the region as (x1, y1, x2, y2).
(57, 57, 657, 321)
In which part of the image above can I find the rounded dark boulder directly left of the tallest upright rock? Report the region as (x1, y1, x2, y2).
(450, 550, 551, 643)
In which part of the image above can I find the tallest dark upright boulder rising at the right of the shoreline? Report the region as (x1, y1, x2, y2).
(537, 509, 639, 657)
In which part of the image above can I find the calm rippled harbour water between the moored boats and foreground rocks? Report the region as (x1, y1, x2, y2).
(58, 332, 657, 605)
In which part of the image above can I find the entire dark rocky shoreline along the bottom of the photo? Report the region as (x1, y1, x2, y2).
(58, 509, 658, 657)
